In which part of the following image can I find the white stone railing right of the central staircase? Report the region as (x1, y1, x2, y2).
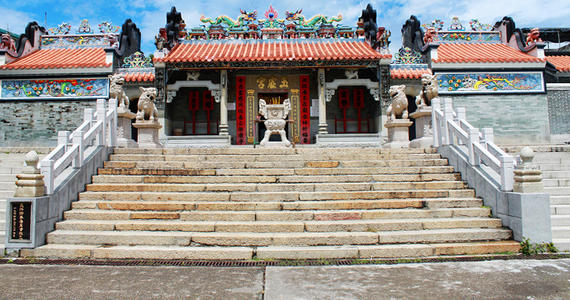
(432, 98, 515, 191)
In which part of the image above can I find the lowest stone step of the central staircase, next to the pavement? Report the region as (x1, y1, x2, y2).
(22, 241, 519, 260)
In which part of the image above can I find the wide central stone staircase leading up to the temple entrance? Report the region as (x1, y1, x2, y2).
(21, 147, 519, 259)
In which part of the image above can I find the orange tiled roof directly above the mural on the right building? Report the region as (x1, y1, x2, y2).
(433, 43, 544, 63)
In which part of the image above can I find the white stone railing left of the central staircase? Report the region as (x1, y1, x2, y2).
(40, 99, 117, 195)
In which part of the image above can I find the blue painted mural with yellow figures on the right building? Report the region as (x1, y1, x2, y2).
(436, 72, 544, 94)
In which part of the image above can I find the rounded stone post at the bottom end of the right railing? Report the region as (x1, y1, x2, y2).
(513, 147, 544, 193)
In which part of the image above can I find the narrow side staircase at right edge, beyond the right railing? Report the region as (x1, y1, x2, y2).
(534, 152, 570, 252)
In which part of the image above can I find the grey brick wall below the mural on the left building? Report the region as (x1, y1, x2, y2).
(0, 99, 96, 147)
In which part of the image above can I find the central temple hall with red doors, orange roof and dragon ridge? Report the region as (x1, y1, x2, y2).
(154, 7, 391, 147)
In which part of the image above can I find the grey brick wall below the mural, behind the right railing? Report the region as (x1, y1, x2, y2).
(442, 94, 550, 144)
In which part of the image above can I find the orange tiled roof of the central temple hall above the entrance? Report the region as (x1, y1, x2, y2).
(155, 39, 391, 62)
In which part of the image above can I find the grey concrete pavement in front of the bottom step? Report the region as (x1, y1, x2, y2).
(0, 259, 570, 300)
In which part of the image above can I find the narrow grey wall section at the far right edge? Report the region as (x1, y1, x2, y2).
(547, 84, 570, 135)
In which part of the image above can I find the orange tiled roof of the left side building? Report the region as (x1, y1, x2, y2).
(0, 48, 111, 70)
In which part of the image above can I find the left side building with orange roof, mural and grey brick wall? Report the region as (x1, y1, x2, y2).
(0, 20, 154, 146)
